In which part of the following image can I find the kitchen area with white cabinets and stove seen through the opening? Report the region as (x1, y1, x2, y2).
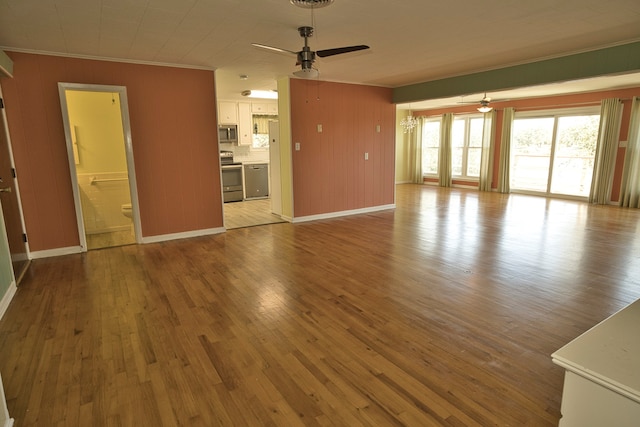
(218, 100, 284, 230)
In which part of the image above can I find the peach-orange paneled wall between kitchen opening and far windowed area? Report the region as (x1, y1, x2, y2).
(290, 79, 396, 217)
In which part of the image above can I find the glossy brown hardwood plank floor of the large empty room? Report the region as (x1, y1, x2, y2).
(0, 185, 640, 426)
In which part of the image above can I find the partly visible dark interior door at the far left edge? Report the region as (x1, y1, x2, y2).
(0, 89, 29, 283)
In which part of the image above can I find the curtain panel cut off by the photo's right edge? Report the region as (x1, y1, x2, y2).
(619, 96, 640, 208)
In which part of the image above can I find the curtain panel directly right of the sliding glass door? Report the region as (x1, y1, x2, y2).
(589, 98, 622, 205)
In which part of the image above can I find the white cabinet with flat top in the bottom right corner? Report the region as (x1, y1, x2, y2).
(551, 300, 640, 427)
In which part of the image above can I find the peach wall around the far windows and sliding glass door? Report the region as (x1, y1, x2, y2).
(413, 87, 640, 202)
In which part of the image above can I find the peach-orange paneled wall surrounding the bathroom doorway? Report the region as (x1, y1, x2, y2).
(1, 52, 222, 251)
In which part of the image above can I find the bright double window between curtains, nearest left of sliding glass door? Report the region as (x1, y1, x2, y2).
(451, 115, 484, 180)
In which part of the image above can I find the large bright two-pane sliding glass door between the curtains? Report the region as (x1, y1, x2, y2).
(511, 109, 600, 197)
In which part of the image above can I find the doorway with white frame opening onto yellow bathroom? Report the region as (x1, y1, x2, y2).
(58, 83, 141, 251)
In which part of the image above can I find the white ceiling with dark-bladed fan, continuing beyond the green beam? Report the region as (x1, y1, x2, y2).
(0, 0, 640, 109)
